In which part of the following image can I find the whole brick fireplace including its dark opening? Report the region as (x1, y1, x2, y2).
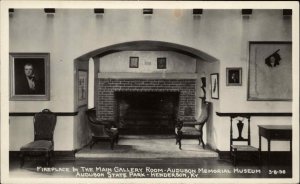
(96, 78, 196, 134)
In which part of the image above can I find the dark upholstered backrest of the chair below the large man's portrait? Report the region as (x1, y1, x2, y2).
(33, 109, 56, 142)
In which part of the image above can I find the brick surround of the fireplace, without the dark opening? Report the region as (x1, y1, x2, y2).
(96, 78, 196, 120)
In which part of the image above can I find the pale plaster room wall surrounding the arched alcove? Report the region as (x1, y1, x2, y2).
(9, 9, 292, 150)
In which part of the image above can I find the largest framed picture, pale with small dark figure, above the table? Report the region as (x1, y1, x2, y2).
(248, 42, 292, 101)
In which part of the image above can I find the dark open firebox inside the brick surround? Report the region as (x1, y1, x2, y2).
(115, 92, 180, 135)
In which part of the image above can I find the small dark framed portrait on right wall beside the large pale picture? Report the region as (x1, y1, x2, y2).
(226, 68, 242, 86)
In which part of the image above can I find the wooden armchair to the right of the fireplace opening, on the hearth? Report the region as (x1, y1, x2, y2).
(175, 102, 210, 149)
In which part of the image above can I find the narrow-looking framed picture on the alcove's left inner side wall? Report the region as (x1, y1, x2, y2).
(77, 70, 88, 106)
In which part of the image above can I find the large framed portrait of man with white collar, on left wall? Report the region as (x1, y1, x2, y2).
(10, 53, 50, 101)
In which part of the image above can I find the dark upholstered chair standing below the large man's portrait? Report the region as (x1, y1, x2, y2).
(20, 109, 56, 167)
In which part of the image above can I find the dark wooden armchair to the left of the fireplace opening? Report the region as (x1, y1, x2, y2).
(86, 109, 119, 149)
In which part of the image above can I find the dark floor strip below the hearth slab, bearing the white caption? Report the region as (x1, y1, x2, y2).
(9, 158, 292, 180)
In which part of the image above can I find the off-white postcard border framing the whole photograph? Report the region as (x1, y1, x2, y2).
(0, 0, 299, 183)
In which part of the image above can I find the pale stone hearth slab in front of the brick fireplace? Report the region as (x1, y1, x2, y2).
(75, 135, 218, 159)
